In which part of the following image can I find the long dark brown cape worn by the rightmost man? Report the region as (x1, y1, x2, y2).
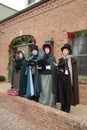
(57, 57, 79, 106)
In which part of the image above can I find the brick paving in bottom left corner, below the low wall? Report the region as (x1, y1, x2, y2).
(0, 103, 36, 130)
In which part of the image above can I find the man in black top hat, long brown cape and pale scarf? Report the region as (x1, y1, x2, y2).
(57, 44, 79, 113)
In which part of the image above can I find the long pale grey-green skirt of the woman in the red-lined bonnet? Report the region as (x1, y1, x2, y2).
(39, 75, 55, 107)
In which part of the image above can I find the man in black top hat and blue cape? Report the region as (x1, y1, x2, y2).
(25, 45, 41, 101)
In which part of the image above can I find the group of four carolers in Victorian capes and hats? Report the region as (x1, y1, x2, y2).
(11, 43, 79, 113)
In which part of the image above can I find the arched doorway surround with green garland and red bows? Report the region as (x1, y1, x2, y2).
(8, 35, 36, 81)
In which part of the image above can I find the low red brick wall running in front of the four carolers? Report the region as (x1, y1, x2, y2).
(0, 93, 87, 130)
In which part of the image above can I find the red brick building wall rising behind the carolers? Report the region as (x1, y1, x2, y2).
(0, 0, 87, 105)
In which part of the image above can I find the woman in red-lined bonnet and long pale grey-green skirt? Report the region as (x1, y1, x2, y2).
(38, 44, 57, 107)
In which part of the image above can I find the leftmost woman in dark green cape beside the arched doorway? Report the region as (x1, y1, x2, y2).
(11, 51, 26, 96)
